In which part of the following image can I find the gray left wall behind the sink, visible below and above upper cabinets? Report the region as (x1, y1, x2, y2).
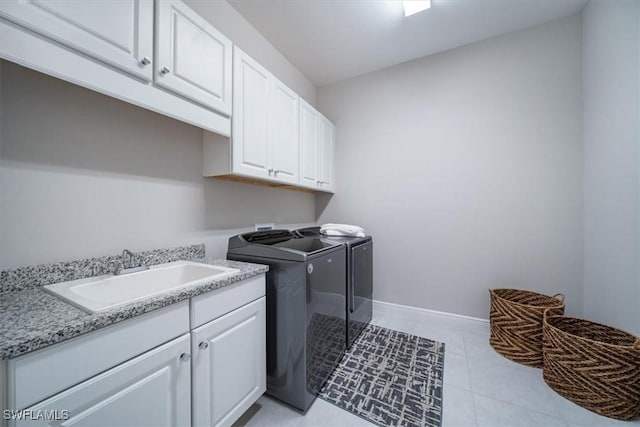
(0, 1, 315, 269)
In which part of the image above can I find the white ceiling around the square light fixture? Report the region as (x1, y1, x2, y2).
(228, 0, 588, 86)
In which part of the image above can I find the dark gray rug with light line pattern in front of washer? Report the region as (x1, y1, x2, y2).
(320, 325, 444, 427)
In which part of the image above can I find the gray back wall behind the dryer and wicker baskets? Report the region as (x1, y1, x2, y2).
(316, 16, 583, 318)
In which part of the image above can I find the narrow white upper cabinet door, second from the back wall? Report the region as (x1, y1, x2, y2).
(299, 99, 319, 188)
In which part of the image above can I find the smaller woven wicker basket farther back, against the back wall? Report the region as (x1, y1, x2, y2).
(489, 289, 564, 368)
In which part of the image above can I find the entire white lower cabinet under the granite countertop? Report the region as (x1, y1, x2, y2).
(0, 274, 266, 427)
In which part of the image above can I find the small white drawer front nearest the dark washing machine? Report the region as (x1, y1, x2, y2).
(191, 274, 265, 329)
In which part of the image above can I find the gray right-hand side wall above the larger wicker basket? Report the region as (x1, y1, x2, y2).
(582, 0, 640, 334)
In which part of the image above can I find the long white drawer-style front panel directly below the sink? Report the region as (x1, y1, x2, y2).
(7, 301, 189, 409)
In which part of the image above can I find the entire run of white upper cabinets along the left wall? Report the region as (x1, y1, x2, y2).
(0, 0, 334, 192)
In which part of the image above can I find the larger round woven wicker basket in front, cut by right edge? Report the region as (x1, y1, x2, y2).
(542, 314, 640, 420)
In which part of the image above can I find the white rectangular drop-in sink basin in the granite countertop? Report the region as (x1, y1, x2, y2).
(44, 261, 239, 313)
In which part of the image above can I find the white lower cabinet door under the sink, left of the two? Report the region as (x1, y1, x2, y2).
(16, 334, 191, 427)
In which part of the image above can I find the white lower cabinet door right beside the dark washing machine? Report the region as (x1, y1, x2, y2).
(191, 297, 266, 426)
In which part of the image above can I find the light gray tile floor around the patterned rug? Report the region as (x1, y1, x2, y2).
(238, 303, 640, 427)
